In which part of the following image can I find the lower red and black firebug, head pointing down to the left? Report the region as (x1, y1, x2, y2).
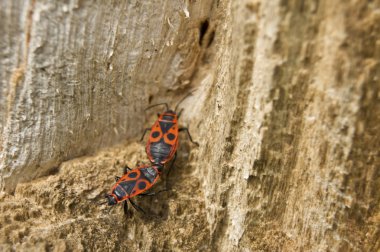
(105, 165, 163, 213)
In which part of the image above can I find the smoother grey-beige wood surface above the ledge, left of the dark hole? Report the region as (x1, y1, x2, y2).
(0, 0, 210, 191)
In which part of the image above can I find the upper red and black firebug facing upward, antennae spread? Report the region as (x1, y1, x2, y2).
(140, 93, 199, 170)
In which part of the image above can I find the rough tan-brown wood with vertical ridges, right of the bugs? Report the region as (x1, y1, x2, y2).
(194, 1, 380, 251)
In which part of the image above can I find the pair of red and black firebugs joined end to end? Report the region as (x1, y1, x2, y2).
(106, 93, 198, 213)
